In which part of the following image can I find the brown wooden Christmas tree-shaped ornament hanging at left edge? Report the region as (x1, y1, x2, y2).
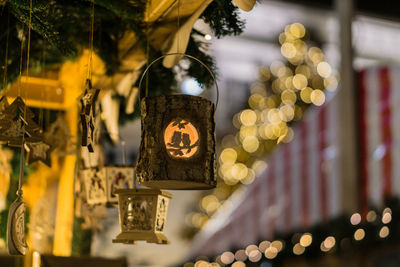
(0, 96, 42, 146)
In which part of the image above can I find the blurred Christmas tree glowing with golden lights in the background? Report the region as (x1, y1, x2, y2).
(186, 23, 338, 234)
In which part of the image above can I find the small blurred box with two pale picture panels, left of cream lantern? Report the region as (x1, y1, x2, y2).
(81, 166, 134, 205)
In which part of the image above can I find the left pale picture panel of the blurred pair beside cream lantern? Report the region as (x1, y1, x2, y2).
(80, 168, 107, 205)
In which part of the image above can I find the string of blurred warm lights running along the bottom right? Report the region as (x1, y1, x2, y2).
(183, 207, 396, 267)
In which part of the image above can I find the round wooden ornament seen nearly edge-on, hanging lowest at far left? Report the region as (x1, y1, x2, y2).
(7, 146, 28, 255)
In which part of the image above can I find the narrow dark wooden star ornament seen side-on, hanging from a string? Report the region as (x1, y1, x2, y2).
(80, 79, 100, 152)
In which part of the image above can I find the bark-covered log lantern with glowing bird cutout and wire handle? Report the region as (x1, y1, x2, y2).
(137, 53, 218, 189)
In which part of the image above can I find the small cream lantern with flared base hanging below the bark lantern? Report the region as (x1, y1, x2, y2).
(112, 188, 172, 244)
